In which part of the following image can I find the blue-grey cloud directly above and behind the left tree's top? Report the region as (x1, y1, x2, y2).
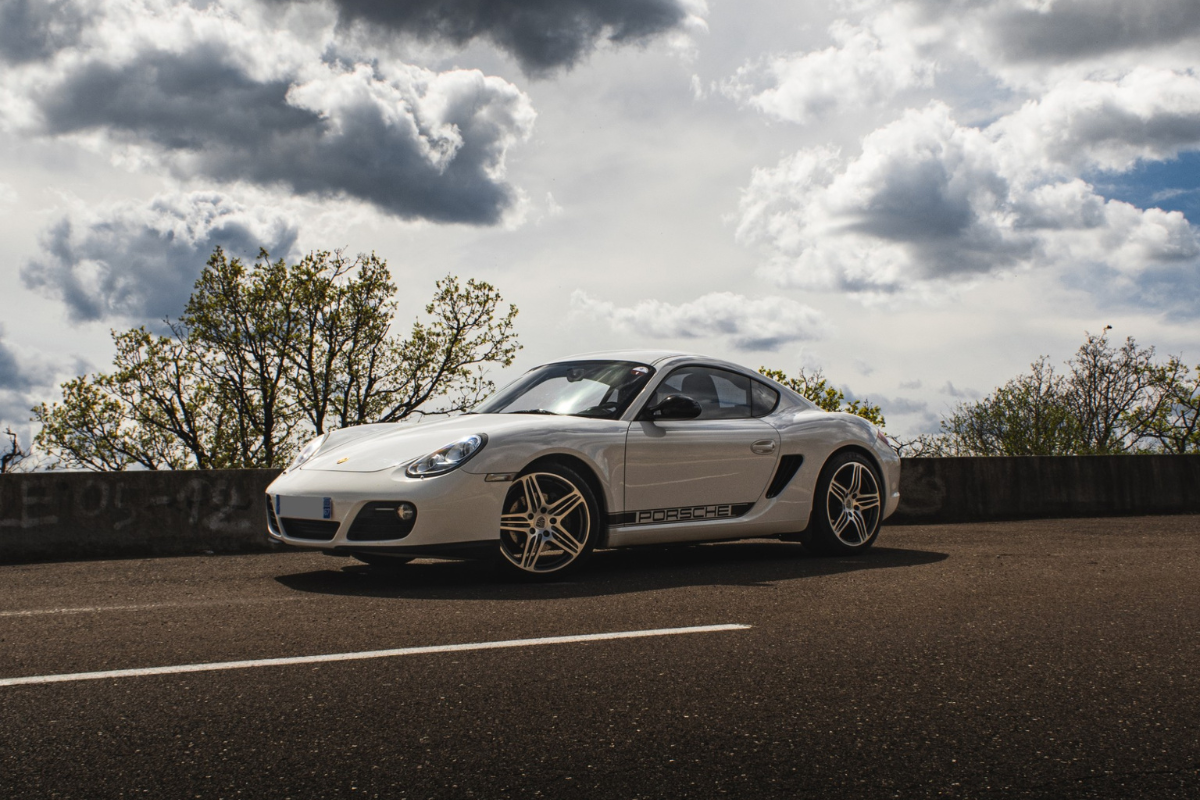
(22, 192, 296, 321)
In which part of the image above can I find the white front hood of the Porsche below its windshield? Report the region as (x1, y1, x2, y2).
(300, 414, 600, 473)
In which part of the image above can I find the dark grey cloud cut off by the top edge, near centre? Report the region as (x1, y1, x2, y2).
(316, 0, 688, 73)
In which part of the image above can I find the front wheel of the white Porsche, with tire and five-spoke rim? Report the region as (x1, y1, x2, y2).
(499, 464, 600, 581)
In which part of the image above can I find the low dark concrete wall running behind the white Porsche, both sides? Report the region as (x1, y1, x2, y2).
(0, 456, 1200, 564)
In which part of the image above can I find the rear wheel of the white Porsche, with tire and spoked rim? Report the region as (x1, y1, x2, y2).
(800, 451, 883, 555)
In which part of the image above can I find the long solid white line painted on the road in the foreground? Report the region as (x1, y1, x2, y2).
(0, 625, 750, 686)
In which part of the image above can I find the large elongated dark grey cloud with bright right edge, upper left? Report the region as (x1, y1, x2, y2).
(38, 43, 533, 224)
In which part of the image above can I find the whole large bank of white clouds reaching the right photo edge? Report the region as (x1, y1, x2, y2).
(737, 70, 1200, 314)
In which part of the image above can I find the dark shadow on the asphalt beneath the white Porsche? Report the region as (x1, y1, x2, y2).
(276, 540, 947, 600)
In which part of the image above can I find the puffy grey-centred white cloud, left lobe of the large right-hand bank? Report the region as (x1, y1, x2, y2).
(737, 104, 1033, 296)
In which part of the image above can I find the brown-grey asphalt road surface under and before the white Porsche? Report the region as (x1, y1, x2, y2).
(0, 517, 1200, 799)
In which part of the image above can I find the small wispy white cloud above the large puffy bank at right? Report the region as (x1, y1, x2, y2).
(721, 19, 935, 124)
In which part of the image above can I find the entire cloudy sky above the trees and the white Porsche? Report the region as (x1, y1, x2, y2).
(0, 0, 1200, 443)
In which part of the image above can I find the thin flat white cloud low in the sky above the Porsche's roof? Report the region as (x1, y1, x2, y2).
(571, 290, 828, 350)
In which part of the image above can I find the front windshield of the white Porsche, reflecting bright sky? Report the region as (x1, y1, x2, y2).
(474, 361, 654, 420)
